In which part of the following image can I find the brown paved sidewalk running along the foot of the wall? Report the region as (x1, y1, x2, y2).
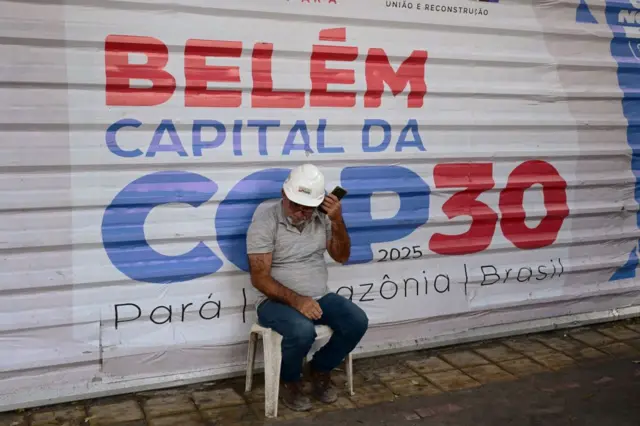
(0, 320, 640, 426)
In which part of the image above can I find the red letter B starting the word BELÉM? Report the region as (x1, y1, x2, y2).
(104, 35, 176, 106)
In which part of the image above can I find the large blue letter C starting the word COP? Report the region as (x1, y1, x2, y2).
(102, 171, 222, 284)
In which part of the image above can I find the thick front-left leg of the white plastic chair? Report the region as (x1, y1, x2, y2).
(262, 331, 282, 418)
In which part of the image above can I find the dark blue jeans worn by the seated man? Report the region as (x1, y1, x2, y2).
(258, 293, 369, 382)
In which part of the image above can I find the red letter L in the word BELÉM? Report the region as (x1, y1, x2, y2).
(251, 43, 305, 108)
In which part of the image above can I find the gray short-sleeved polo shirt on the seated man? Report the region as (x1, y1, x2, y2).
(247, 202, 331, 306)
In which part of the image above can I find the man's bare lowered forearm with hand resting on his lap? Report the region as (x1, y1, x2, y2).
(249, 253, 322, 320)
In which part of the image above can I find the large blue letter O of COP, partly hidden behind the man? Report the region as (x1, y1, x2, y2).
(215, 169, 290, 272)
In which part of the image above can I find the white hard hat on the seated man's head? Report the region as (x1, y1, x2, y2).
(282, 164, 325, 207)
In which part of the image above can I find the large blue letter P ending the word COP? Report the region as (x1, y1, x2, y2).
(341, 166, 431, 264)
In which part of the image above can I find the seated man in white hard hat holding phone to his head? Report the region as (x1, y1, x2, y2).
(247, 164, 369, 411)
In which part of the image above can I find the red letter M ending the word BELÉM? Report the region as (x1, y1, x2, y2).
(364, 49, 428, 108)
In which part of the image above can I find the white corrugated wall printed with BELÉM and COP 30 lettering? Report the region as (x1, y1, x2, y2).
(0, 0, 640, 409)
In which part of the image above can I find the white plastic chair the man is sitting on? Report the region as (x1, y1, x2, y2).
(245, 324, 354, 418)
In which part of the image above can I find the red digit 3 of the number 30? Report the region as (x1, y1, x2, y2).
(429, 163, 498, 255)
